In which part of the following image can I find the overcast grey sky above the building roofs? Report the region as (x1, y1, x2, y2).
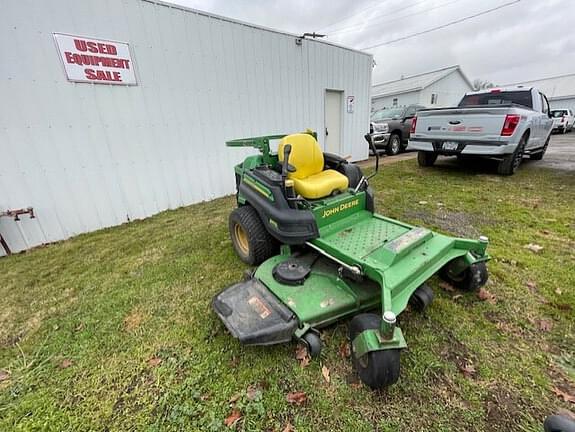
(172, 0, 575, 84)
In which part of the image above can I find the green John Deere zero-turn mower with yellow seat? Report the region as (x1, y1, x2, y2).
(213, 130, 489, 388)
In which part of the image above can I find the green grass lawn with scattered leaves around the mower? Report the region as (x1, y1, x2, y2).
(0, 160, 575, 432)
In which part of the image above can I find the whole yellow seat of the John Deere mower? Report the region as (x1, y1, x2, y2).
(278, 134, 349, 199)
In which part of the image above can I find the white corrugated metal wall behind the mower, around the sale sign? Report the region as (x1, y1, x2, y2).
(0, 0, 372, 253)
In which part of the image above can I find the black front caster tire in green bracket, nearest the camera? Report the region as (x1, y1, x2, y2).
(349, 314, 401, 390)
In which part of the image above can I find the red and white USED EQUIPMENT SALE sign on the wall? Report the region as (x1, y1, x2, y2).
(54, 33, 138, 85)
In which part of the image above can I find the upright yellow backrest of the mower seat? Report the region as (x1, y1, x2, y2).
(278, 134, 323, 179)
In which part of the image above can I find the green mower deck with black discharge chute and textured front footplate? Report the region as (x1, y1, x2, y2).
(216, 210, 488, 345)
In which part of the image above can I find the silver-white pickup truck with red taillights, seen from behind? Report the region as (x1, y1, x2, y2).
(407, 86, 553, 175)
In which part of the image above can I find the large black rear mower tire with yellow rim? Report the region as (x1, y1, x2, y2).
(229, 205, 278, 265)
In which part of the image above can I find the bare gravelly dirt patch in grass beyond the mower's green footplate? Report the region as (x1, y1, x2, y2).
(405, 208, 494, 238)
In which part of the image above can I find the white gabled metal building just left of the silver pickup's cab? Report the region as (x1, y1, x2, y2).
(371, 65, 473, 111)
